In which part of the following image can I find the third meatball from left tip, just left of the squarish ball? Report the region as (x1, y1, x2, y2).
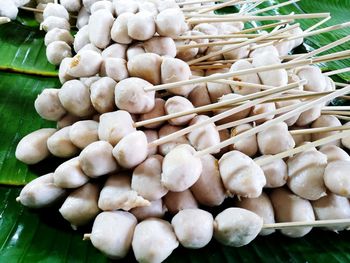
(69, 120, 98, 149)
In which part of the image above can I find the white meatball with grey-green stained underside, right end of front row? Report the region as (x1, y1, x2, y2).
(214, 208, 263, 247)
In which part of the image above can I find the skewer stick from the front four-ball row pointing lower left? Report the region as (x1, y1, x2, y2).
(148, 82, 304, 147)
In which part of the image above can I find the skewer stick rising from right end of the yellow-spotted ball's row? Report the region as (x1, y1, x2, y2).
(187, 24, 299, 65)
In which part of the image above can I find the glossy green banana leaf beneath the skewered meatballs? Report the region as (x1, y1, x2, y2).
(0, 0, 350, 263)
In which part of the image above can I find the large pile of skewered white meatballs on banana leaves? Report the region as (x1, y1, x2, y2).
(8, 0, 350, 262)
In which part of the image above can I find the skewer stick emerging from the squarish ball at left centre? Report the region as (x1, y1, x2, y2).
(134, 81, 305, 128)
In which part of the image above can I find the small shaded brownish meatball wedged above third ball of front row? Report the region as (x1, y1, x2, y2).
(163, 189, 198, 214)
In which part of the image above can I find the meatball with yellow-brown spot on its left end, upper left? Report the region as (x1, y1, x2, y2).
(67, 50, 102, 78)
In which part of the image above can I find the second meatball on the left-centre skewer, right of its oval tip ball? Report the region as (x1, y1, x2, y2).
(47, 126, 79, 158)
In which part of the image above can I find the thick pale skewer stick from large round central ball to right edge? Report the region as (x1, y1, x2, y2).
(196, 86, 350, 157)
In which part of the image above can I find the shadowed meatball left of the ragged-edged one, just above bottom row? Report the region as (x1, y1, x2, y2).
(59, 183, 100, 230)
